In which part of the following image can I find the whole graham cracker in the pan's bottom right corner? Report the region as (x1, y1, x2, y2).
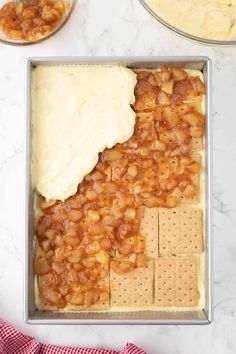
(154, 257, 199, 307)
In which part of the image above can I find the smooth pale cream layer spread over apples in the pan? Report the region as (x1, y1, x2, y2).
(31, 65, 136, 200)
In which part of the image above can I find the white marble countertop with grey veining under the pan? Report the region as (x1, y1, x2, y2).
(0, 0, 236, 354)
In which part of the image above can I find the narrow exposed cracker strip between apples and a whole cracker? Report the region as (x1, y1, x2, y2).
(140, 208, 159, 258)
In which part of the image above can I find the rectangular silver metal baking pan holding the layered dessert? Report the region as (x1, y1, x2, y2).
(24, 57, 213, 325)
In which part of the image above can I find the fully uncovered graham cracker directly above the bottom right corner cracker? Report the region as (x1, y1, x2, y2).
(159, 207, 203, 255)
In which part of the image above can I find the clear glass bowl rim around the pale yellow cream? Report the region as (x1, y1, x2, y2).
(139, 0, 236, 46)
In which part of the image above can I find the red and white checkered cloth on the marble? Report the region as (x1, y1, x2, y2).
(0, 319, 146, 354)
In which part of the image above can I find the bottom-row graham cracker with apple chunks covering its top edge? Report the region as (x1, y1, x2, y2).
(110, 261, 154, 307)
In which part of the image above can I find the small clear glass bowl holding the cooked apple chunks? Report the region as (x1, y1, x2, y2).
(0, 0, 76, 45)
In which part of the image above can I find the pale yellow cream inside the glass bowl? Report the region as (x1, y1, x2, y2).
(147, 0, 236, 40)
